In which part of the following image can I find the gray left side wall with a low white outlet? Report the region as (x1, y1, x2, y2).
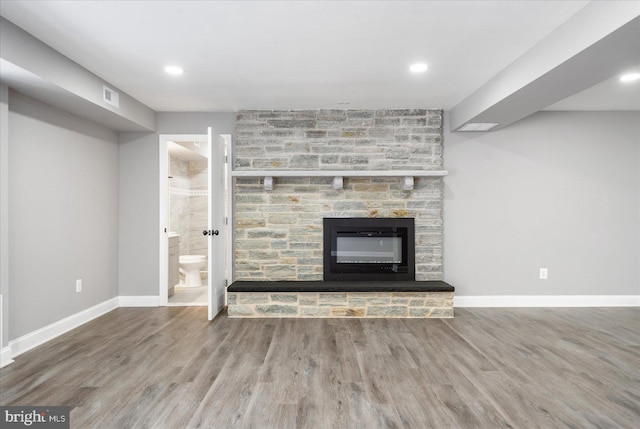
(9, 91, 118, 340)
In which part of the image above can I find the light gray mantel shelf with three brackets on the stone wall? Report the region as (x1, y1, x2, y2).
(231, 170, 448, 191)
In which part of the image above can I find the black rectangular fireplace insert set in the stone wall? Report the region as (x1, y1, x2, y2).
(323, 218, 415, 281)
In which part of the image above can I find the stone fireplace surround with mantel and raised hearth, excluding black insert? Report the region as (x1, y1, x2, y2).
(228, 109, 453, 317)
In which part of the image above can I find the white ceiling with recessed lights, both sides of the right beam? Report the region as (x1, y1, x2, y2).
(0, 0, 640, 111)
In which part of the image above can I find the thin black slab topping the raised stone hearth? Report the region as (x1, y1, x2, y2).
(227, 280, 454, 292)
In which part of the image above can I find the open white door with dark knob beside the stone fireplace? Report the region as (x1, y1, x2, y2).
(208, 128, 227, 320)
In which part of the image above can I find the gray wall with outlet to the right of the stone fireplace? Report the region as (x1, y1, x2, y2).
(444, 112, 640, 295)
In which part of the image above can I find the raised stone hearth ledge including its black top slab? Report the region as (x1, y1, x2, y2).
(227, 281, 454, 319)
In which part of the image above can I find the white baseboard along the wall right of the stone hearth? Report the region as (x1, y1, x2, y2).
(453, 295, 640, 307)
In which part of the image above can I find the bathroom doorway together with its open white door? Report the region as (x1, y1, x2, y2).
(159, 129, 227, 320)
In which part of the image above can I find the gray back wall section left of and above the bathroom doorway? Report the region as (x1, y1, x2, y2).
(118, 112, 235, 296)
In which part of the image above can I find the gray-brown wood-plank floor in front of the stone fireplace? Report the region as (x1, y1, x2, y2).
(0, 307, 640, 429)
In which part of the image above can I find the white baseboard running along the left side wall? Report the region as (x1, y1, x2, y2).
(9, 297, 118, 359)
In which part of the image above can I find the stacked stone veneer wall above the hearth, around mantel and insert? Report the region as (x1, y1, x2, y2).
(233, 109, 443, 281)
